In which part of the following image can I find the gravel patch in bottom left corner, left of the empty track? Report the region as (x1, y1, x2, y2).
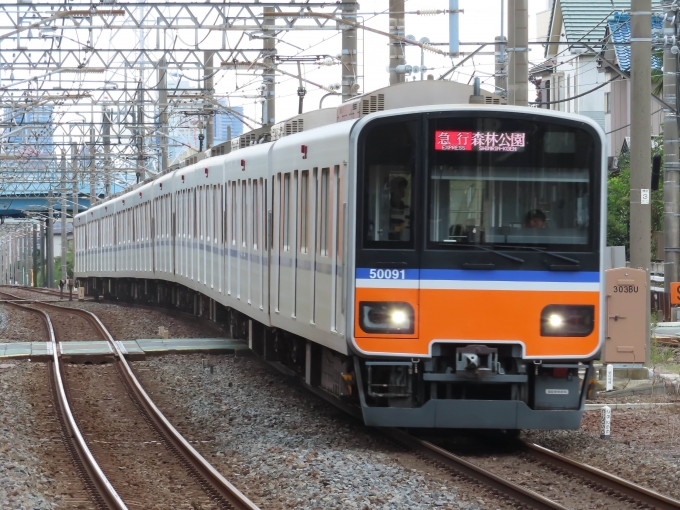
(0, 360, 92, 510)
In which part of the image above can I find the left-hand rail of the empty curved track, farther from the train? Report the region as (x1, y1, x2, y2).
(3, 292, 127, 510)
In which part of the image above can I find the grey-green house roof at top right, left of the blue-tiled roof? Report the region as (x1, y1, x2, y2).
(546, 0, 661, 56)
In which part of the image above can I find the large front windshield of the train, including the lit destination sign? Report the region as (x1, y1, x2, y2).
(427, 117, 597, 250)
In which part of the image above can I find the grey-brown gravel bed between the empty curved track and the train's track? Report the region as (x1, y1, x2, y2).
(134, 355, 502, 510)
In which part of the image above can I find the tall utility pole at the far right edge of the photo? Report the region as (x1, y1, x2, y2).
(663, 0, 680, 300)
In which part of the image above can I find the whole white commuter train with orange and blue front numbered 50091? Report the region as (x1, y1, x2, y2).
(74, 81, 607, 433)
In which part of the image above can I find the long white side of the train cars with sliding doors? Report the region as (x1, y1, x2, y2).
(75, 120, 357, 354)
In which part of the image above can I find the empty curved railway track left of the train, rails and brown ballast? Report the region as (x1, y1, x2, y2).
(0, 292, 257, 510)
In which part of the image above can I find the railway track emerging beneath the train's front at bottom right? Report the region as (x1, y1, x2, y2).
(384, 429, 680, 510)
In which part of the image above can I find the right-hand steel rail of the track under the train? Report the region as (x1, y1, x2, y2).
(521, 441, 680, 510)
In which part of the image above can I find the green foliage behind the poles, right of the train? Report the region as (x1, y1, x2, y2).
(607, 135, 663, 258)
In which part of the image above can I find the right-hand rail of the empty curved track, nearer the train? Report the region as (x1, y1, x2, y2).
(27, 296, 259, 510)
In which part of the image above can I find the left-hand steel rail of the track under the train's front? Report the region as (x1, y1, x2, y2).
(381, 429, 567, 510)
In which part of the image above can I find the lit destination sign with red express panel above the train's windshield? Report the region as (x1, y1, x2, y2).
(434, 131, 526, 152)
